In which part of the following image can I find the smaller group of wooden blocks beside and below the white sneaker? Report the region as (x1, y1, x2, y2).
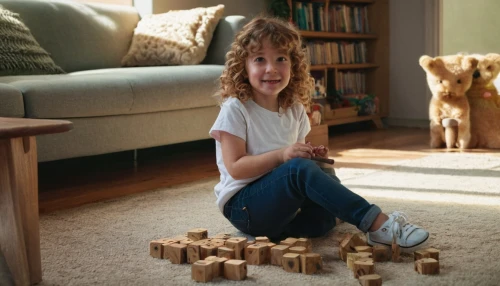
(339, 233, 439, 286)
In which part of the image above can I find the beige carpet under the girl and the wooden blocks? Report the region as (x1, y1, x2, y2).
(41, 153, 500, 286)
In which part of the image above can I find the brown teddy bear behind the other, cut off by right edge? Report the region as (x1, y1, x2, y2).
(467, 54, 500, 148)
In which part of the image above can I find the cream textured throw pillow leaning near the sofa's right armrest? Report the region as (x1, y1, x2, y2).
(122, 5, 224, 66)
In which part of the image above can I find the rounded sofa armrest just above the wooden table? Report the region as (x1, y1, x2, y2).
(0, 83, 24, 117)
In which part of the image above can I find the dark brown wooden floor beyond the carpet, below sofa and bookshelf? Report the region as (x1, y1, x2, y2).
(39, 125, 500, 213)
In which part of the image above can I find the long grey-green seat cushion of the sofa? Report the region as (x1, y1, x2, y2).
(0, 65, 223, 118)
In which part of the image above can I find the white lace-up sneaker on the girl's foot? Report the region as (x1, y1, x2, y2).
(367, 211, 429, 252)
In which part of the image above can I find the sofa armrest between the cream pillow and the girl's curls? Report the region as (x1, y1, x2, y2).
(202, 16, 247, 65)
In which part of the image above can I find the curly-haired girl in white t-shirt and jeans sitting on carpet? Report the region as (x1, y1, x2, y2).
(210, 17, 429, 251)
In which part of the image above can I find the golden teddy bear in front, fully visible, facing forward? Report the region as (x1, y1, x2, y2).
(419, 55, 478, 149)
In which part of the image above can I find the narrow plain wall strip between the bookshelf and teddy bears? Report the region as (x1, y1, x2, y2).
(387, 0, 429, 126)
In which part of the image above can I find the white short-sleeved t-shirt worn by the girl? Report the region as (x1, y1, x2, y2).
(210, 98, 311, 212)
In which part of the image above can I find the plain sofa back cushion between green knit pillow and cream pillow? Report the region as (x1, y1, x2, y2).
(0, 0, 139, 72)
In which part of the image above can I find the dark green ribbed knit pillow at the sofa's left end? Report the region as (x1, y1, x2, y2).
(0, 6, 64, 76)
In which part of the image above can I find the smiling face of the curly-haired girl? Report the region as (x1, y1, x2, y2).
(245, 40, 291, 98)
